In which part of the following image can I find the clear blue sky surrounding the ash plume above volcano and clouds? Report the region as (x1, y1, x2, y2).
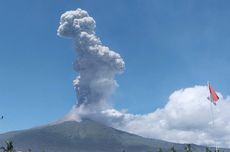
(0, 0, 230, 132)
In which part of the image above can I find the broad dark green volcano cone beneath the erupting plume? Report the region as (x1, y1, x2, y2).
(0, 119, 227, 152)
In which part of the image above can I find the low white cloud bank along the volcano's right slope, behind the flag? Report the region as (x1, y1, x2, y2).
(63, 86, 230, 147)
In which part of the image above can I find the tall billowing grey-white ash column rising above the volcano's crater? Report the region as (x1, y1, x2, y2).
(57, 9, 125, 111)
